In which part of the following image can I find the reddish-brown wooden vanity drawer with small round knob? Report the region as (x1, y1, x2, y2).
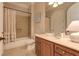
(55, 44, 79, 56)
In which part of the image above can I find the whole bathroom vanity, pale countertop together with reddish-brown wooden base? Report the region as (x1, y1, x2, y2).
(35, 34, 79, 56)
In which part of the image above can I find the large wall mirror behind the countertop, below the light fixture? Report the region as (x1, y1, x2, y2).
(46, 2, 73, 33)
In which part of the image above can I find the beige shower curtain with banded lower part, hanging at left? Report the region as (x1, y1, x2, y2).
(4, 8, 16, 43)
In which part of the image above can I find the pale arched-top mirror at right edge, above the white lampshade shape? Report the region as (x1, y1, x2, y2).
(67, 3, 79, 27)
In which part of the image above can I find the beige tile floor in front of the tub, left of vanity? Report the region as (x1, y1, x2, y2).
(3, 44, 35, 56)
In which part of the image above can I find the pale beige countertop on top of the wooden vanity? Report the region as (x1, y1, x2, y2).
(35, 34, 79, 51)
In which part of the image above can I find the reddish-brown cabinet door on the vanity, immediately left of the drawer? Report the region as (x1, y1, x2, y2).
(41, 39, 54, 56)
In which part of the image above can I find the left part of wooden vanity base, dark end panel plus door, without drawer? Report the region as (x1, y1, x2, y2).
(35, 37, 54, 56)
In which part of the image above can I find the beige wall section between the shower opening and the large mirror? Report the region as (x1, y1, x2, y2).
(31, 3, 45, 38)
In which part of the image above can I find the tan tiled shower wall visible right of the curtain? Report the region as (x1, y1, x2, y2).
(16, 15, 28, 38)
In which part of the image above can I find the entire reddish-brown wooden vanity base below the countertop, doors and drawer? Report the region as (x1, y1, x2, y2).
(35, 36, 79, 56)
